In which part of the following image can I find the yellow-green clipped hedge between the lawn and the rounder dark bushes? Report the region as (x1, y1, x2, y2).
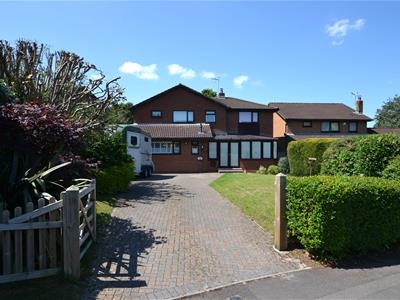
(287, 138, 335, 176)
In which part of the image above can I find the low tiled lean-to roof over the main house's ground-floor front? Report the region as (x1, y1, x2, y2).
(137, 124, 213, 139)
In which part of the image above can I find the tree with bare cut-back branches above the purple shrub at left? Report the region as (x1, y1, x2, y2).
(0, 40, 124, 127)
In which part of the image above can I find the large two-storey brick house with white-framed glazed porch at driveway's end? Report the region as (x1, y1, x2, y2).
(132, 84, 277, 173)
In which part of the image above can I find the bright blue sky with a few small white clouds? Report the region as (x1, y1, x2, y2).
(0, 1, 400, 123)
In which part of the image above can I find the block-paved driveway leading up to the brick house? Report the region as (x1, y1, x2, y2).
(85, 173, 302, 300)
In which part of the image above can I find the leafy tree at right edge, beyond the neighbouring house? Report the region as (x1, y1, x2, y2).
(375, 95, 400, 128)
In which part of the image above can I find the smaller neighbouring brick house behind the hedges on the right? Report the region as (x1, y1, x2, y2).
(268, 97, 372, 152)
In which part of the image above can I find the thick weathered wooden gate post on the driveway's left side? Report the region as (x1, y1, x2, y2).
(61, 186, 81, 279)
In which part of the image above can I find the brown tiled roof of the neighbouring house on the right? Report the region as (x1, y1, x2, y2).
(268, 102, 371, 121)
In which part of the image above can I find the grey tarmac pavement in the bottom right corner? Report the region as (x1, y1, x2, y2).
(190, 256, 400, 300)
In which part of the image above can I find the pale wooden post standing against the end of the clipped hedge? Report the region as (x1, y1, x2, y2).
(275, 173, 287, 251)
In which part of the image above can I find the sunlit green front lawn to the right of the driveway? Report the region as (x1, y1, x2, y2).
(211, 173, 275, 234)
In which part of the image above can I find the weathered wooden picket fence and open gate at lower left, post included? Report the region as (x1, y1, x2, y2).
(0, 180, 96, 283)
